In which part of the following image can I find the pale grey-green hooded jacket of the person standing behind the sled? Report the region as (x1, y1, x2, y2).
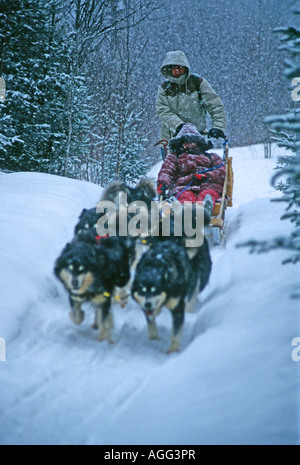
(156, 51, 226, 140)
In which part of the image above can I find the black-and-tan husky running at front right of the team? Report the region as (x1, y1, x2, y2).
(131, 238, 211, 353)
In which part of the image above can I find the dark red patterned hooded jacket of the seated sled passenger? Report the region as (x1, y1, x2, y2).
(157, 123, 226, 197)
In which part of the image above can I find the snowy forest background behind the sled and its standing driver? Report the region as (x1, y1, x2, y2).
(0, 0, 295, 186)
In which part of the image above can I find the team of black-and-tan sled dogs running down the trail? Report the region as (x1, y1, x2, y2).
(54, 179, 211, 353)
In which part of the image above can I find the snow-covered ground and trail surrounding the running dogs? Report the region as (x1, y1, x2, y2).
(0, 146, 300, 445)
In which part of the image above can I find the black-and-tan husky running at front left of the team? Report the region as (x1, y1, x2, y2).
(54, 233, 134, 342)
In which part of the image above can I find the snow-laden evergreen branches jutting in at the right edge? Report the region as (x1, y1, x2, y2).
(241, 9, 300, 276)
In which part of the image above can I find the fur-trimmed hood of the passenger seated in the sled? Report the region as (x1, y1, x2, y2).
(169, 123, 213, 156)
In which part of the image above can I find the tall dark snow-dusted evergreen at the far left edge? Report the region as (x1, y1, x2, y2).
(0, 0, 61, 170)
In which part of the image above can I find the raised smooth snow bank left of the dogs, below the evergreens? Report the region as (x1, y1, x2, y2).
(0, 173, 101, 342)
